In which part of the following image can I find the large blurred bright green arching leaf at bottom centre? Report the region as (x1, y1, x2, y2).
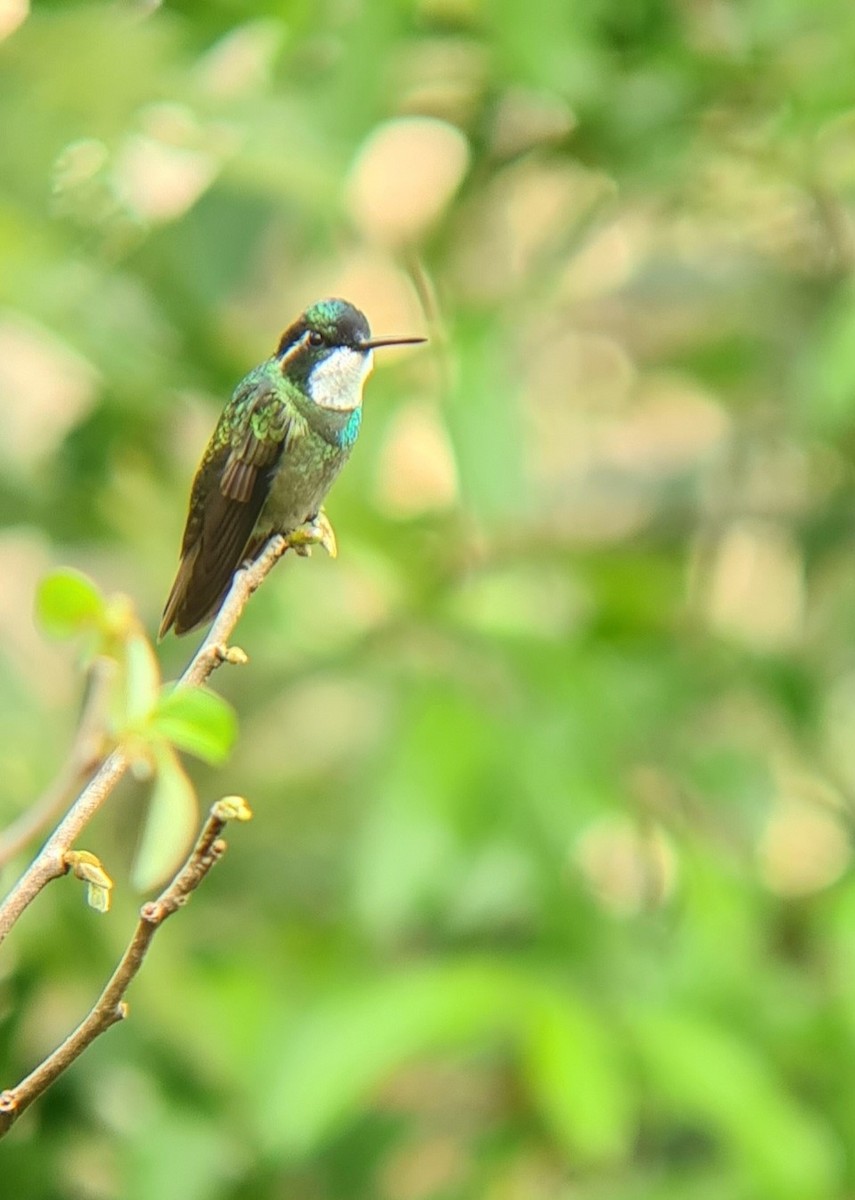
(259, 959, 634, 1163)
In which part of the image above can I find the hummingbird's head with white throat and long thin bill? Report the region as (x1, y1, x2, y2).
(275, 300, 425, 413)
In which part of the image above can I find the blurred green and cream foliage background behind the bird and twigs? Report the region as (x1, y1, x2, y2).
(0, 0, 855, 1200)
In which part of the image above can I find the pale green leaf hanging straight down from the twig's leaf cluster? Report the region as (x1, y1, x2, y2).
(131, 745, 199, 892)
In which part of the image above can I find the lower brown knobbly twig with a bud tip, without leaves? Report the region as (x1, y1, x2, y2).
(0, 792, 253, 1138)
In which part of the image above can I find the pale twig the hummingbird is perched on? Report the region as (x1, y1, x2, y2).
(0, 535, 289, 943)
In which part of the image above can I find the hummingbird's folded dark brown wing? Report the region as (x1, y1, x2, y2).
(160, 384, 289, 637)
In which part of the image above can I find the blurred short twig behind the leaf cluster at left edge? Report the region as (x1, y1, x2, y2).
(0, 655, 115, 869)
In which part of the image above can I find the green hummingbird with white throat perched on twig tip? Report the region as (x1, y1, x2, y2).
(160, 299, 425, 637)
